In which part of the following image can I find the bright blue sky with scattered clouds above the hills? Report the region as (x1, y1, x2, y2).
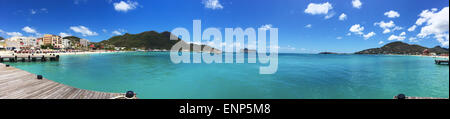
(0, 0, 449, 53)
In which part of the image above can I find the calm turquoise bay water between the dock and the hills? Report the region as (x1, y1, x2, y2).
(4, 52, 449, 99)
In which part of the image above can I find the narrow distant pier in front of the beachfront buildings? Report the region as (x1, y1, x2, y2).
(0, 54, 59, 62)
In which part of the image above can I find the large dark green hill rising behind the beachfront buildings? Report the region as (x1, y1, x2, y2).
(94, 31, 221, 52)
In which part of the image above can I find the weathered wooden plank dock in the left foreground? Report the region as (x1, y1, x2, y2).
(0, 63, 131, 99)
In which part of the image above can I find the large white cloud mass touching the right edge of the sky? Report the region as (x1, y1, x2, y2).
(416, 7, 449, 47)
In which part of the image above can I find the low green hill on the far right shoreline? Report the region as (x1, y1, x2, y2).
(355, 41, 449, 55)
